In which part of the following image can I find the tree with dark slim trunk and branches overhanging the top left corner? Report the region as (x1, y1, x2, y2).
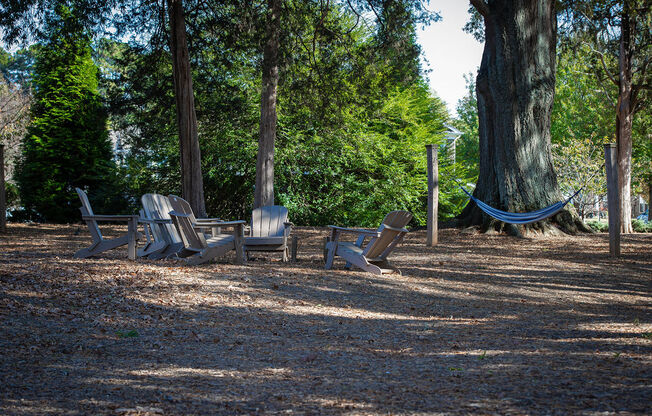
(0, 0, 206, 215)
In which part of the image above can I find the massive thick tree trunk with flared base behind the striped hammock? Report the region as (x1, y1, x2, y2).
(458, 0, 585, 235)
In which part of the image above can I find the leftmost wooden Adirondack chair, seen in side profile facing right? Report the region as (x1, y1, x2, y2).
(74, 188, 141, 260)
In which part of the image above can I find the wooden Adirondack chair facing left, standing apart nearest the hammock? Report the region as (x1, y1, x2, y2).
(326, 211, 412, 275)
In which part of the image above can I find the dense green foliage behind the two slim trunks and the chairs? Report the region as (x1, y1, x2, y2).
(100, 2, 452, 226)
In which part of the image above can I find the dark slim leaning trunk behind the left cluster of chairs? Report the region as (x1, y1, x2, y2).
(168, 0, 206, 217)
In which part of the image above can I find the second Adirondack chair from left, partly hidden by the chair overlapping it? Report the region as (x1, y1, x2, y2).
(138, 194, 194, 260)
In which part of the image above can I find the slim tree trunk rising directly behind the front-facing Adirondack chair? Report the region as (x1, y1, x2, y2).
(254, 0, 281, 208)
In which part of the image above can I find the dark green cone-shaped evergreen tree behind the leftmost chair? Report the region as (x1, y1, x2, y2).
(17, 7, 120, 222)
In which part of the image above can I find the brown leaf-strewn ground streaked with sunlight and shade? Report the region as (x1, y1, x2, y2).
(0, 225, 652, 415)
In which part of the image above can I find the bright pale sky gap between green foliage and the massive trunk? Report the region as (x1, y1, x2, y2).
(417, 0, 483, 115)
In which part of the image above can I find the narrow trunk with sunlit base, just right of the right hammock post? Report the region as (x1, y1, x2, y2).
(616, 2, 634, 233)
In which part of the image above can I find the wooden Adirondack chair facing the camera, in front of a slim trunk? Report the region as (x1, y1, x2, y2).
(244, 205, 292, 261)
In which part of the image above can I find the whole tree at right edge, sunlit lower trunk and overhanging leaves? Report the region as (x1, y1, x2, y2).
(561, 0, 652, 233)
